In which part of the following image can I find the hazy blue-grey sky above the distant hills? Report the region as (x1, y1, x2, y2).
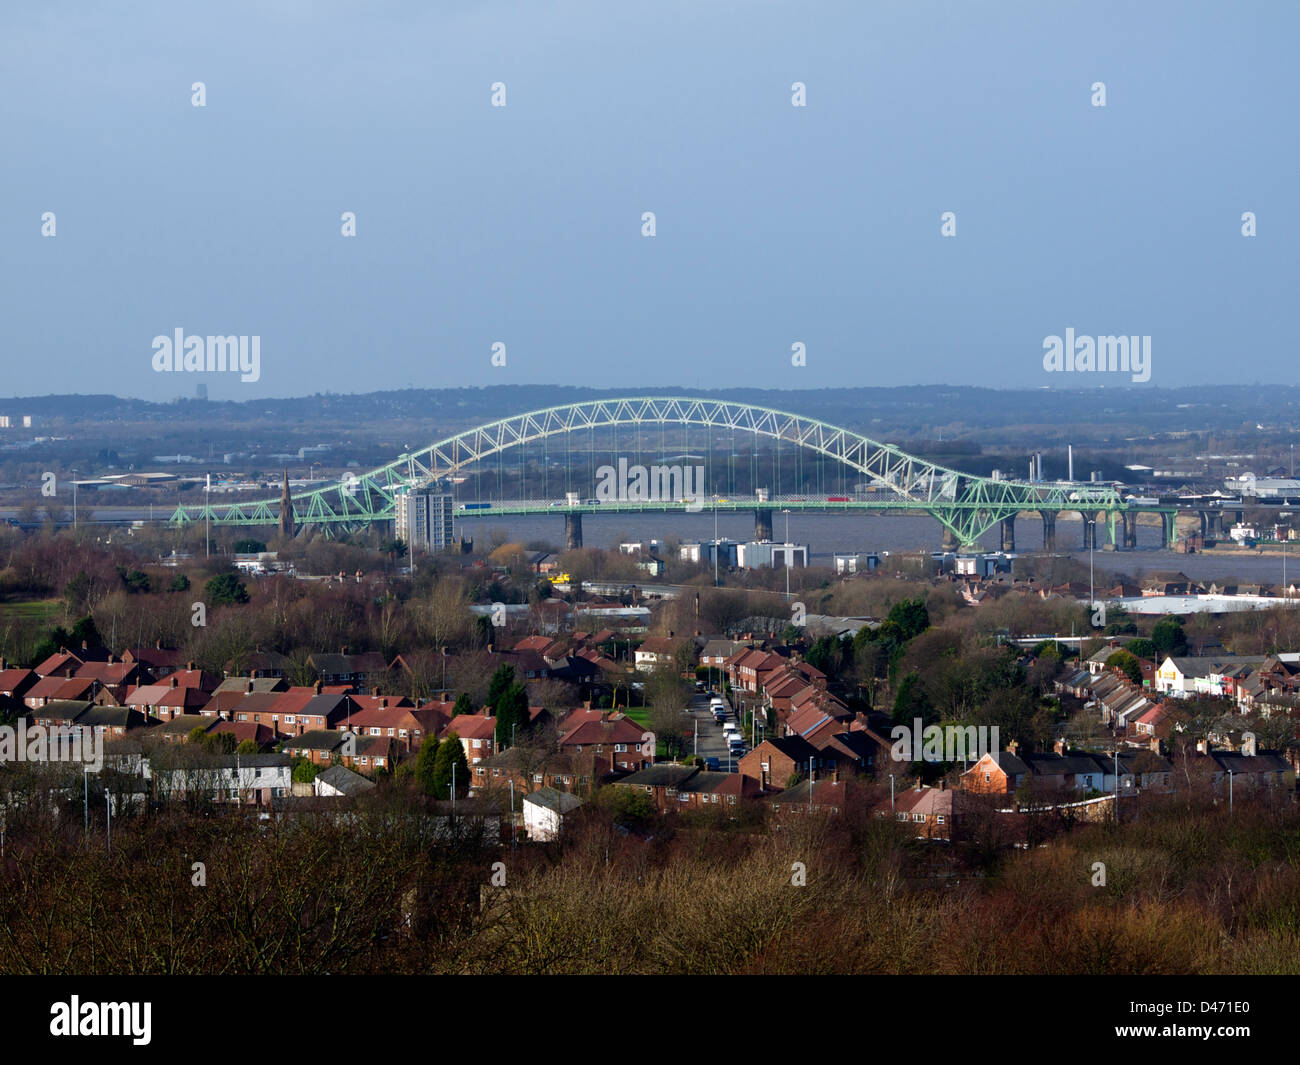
(0, 0, 1300, 401)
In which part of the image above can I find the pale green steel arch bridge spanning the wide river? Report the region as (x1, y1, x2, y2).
(170, 397, 1171, 545)
